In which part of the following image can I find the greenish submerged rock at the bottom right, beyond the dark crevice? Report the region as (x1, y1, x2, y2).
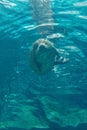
(41, 96, 87, 127)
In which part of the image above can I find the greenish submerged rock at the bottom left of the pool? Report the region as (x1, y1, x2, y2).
(0, 101, 48, 130)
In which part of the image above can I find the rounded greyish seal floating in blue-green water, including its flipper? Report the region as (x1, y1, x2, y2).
(29, 39, 67, 74)
